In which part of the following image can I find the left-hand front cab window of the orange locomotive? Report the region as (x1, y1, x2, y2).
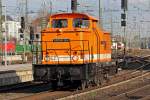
(52, 19, 68, 28)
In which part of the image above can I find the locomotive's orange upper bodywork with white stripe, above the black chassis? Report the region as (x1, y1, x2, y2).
(41, 13, 111, 64)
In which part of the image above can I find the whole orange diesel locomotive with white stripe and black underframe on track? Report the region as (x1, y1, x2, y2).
(33, 13, 117, 88)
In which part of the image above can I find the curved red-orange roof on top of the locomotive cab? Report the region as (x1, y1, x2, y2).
(51, 13, 98, 21)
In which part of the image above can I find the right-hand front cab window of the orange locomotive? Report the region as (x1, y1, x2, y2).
(73, 18, 89, 28)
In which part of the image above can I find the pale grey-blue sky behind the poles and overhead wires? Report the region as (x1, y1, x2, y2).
(2, 0, 150, 37)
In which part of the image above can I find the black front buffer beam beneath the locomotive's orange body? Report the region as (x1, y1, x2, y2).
(33, 63, 98, 82)
